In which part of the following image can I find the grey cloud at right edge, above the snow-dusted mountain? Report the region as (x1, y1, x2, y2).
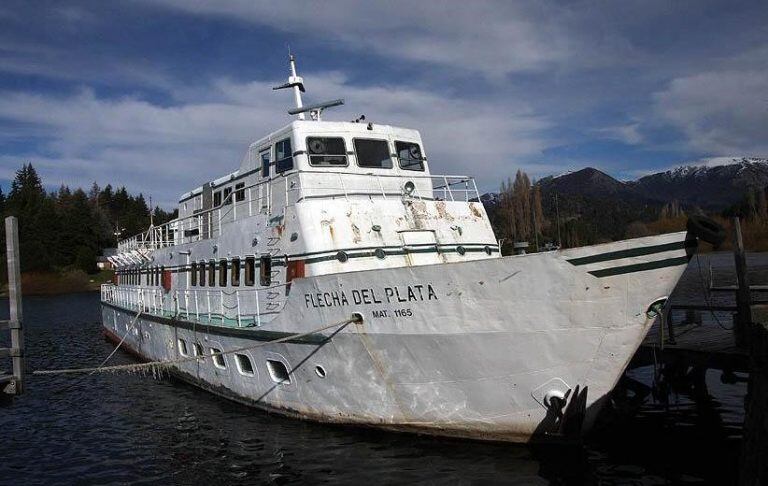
(653, 69, 768, 156)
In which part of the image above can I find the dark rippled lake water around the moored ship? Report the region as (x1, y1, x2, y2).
(0, 252, 757, 485)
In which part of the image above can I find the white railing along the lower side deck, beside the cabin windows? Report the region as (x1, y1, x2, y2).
(101, 284, 268, 327)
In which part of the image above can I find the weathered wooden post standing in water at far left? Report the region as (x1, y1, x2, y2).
(5, 216, 24, 395)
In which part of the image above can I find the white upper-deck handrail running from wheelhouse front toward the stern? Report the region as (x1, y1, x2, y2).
(118, 169, 480, 253)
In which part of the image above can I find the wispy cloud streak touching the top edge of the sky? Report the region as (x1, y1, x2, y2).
(145, 0, 628, 78)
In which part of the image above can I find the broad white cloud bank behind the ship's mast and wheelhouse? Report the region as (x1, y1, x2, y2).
(0, 73, 549, 206)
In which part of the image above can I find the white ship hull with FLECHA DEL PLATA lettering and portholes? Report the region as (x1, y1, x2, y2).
(102, 233, 695, 442)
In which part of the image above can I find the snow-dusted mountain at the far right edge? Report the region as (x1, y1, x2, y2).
(628, 157, 768, 210)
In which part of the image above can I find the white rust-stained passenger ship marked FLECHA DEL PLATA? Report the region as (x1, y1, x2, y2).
(101, 56, 711, 442)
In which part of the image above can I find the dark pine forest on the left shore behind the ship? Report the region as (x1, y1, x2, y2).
(0, 164, 175, 280)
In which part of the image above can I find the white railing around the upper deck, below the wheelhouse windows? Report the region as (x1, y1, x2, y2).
(118, 170, 480, 252)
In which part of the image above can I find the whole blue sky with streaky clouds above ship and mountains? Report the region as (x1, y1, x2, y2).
(0, 0, 768, 208)
